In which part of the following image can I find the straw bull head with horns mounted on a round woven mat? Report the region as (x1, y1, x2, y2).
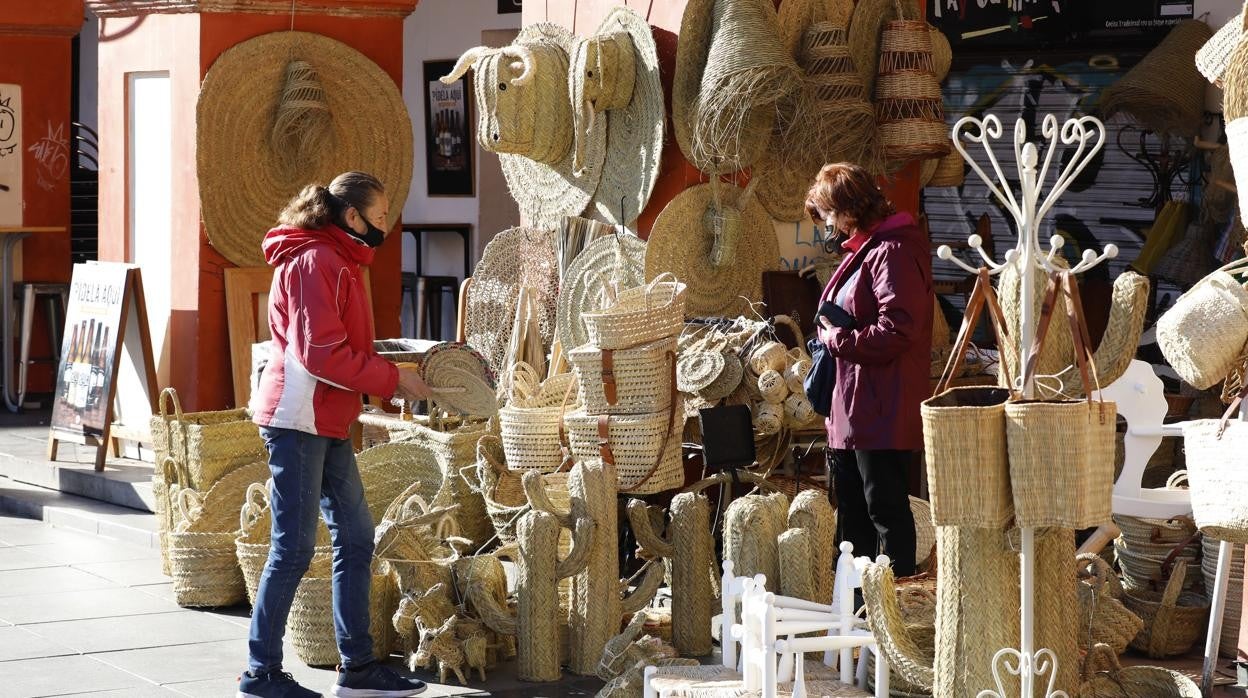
(443, 24, 607, 230)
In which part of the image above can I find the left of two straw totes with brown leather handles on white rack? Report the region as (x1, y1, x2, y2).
(921, 268, 1013, 528)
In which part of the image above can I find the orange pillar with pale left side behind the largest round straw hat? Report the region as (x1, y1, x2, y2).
(100, 14, 403, 410)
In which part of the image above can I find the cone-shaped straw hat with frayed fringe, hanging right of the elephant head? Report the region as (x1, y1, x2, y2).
(671, 0, 801, 174)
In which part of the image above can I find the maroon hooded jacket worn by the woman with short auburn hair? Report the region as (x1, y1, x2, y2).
(821, 214, 932, 451)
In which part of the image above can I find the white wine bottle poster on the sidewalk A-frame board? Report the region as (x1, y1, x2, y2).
(51, 265, 131, 438)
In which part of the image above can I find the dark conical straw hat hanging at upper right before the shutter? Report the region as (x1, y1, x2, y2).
(1098, 20, 1208, 137)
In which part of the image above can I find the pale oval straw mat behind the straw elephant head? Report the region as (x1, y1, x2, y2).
(569, 7, 666, 227)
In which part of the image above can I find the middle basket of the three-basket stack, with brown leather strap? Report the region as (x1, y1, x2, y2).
(568, 337, 676, 415)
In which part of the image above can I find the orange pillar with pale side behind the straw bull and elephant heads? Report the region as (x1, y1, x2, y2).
(523, 0, 922, 237)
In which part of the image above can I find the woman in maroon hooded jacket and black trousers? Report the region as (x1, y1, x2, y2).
(806, 162, 932, 577)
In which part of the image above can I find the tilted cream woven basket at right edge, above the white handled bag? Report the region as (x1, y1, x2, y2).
(1157, 257, 1248, 390)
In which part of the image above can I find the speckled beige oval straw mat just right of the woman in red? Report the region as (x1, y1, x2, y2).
(464, 227, 559, 372)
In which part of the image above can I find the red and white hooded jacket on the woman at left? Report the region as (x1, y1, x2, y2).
(251, 225, 398, 438)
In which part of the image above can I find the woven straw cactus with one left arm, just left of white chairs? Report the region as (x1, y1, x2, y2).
(628, 492, 715, 657)
